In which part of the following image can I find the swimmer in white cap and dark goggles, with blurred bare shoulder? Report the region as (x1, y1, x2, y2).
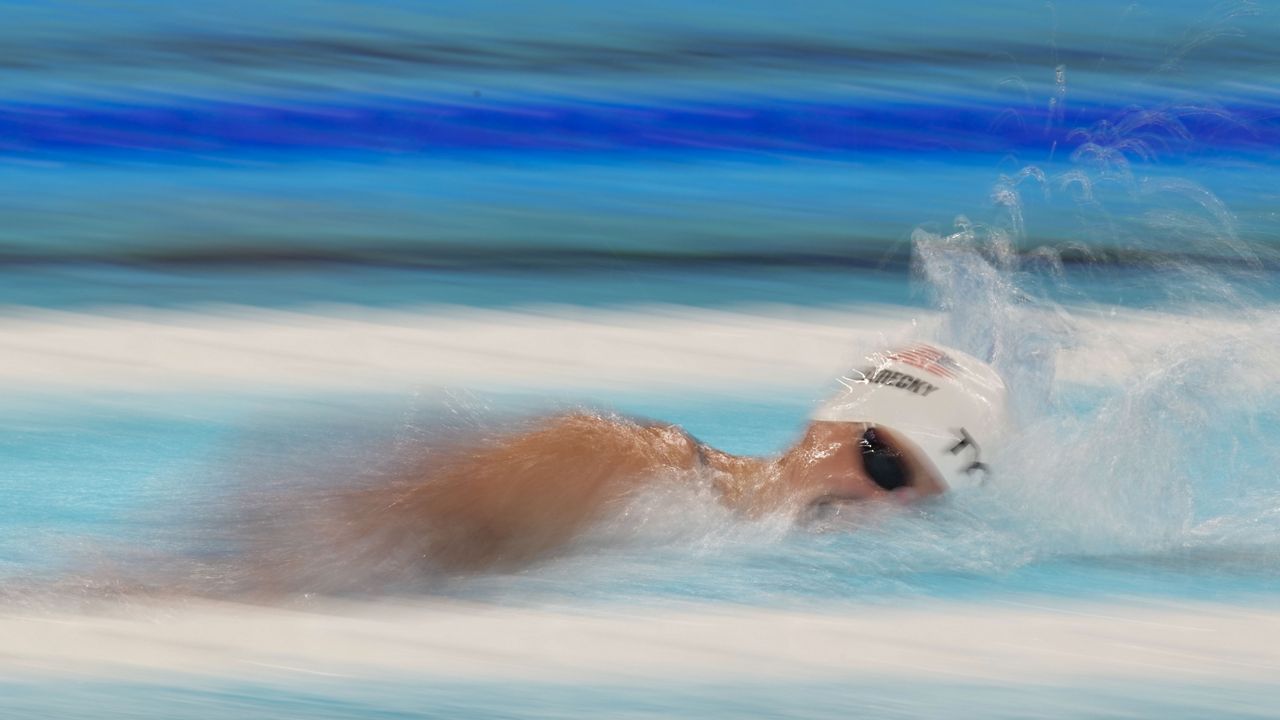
(332, 343, 1006, 571)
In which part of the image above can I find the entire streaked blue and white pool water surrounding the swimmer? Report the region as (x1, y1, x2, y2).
(0, 0, 1280, 719)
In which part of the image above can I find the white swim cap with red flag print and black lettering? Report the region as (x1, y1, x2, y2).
(813, 343, 1007, 488)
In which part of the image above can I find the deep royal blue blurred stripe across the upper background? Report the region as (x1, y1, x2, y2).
(0, 100, 1280, 160)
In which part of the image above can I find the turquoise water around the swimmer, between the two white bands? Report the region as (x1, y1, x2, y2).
(0, 376, 1280, 607)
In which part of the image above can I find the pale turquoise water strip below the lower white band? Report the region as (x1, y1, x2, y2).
(0, 682, 1277, 720)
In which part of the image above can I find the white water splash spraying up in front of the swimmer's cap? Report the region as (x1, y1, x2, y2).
(913, 95, 1280, 559)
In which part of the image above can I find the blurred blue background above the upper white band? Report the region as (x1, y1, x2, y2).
(0, 0, 1280, 307)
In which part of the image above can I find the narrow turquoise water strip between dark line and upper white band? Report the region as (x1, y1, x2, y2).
(0, 260, 1280, 314)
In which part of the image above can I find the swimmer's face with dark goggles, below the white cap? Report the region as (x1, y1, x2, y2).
(782, 421, 946, 507)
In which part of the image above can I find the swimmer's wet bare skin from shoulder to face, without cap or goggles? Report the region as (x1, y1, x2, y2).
(344, 414, 943, 571)
